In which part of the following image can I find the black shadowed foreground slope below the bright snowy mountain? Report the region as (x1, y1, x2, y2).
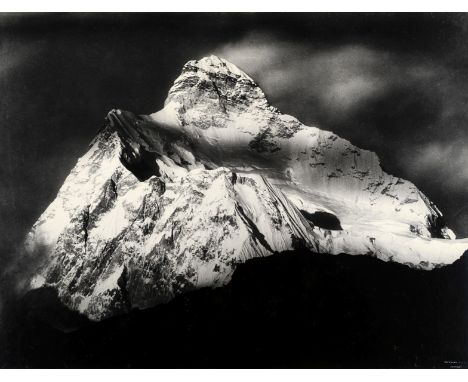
(1, 251, 468, 368)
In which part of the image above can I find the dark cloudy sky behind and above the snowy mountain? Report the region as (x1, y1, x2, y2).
(0, 14, 468, 265)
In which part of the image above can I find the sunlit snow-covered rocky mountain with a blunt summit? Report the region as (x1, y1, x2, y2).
(25, 56, 468, 320)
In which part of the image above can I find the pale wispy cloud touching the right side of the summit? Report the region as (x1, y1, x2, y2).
(216, 33, 435, 118)
